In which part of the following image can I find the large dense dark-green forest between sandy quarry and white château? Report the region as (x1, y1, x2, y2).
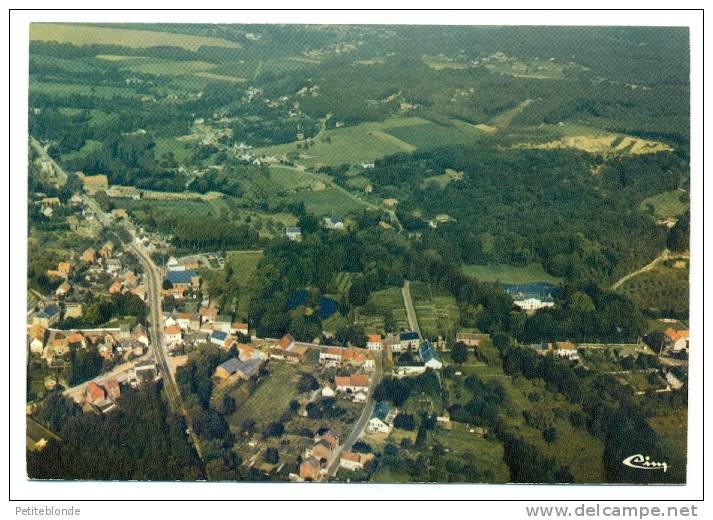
(367, 143, 688, 281)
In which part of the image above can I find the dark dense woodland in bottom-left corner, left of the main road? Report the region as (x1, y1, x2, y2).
(27, 385, 205, 481)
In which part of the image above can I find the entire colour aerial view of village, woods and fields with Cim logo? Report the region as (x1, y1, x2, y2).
(25, 22, 688, 489)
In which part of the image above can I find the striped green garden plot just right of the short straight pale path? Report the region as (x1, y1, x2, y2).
(411, 282, 459, 338)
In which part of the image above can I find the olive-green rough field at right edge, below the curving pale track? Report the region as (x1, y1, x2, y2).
(619, 260, 689, 315)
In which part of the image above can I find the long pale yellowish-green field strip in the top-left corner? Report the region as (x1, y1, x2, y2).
(30, 23, 241, 51)
